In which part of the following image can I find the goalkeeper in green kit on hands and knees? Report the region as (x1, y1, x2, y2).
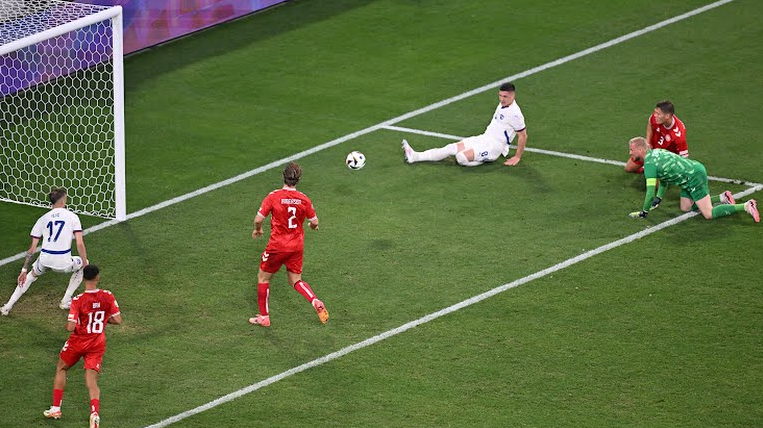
(628, 137, 760, 223)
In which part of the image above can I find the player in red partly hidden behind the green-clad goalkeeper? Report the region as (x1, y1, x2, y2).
(625, 101, 689, 173)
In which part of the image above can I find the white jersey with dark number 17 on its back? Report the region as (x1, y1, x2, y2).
(31, 208, 82, 254)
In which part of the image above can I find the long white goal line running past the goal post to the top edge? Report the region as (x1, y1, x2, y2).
(0, 0, 734, 267)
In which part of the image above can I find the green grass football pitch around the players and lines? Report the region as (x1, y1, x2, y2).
(0, 0, 763, 428)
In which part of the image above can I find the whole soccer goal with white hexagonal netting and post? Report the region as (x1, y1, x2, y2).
(0, 0, 126, 220)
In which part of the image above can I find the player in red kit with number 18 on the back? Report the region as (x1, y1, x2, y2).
(43, 264, 122, 428)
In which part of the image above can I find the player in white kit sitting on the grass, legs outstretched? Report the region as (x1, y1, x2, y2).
(403, 83, 527, 166)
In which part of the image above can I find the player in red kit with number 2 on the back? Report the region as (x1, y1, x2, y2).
(249, 162, 329, 327)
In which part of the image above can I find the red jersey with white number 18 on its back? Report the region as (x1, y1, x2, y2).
(69, 289, 119, 348)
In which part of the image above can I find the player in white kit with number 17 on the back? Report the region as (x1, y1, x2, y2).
(0, 188, 87, 315)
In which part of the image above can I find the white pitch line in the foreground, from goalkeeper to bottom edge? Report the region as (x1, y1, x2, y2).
(145, 182, 763, 428)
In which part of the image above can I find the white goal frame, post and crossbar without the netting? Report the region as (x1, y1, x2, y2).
(0, 0, 127, 221)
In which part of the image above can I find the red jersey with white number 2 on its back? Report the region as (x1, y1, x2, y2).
(257, 187, 316, 252)
